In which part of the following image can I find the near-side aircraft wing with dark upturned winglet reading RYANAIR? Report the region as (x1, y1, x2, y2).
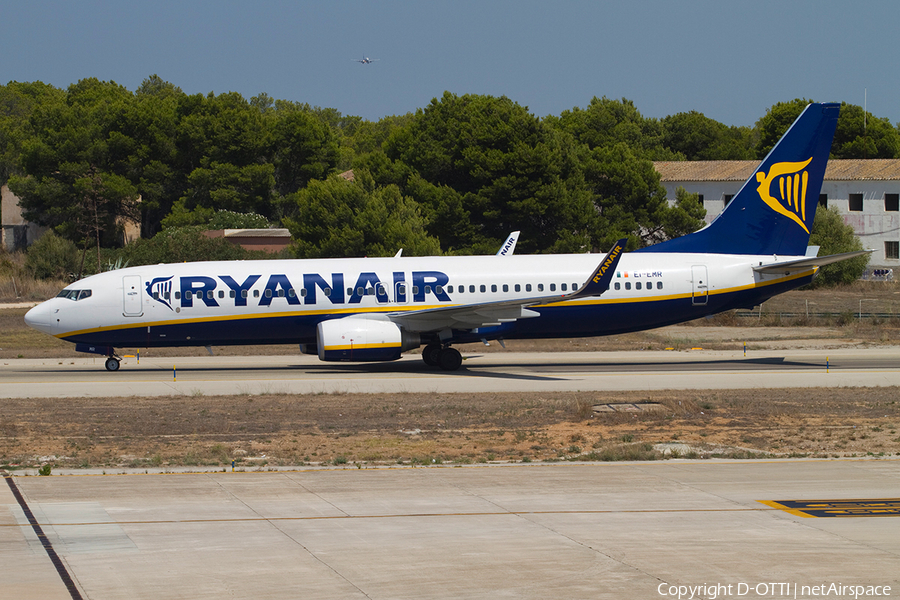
(388, 239, 626, 331)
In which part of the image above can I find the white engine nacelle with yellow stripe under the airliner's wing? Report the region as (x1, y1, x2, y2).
(316, 317, 421, 362)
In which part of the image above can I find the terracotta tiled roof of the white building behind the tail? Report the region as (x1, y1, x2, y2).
(653, 158, 900, 182)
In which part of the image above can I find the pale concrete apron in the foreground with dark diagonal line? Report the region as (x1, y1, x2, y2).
(0, 460, 900, 600)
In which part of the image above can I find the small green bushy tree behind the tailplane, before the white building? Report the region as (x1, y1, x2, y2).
(809, 207, 869, 288)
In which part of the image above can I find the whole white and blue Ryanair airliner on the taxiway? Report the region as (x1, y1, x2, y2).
(25, 104, 861, 371)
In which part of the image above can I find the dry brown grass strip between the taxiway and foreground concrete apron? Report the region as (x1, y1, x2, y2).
(0, 388, 900, 469)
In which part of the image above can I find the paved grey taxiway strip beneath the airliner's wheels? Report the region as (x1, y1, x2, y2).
(0, 347, 900, 398)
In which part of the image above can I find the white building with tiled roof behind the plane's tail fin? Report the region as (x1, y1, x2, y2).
(654, 159, 900, 269)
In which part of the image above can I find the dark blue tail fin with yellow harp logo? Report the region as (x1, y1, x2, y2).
(639, 104, 840, 256)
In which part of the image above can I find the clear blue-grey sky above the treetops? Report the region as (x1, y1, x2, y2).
(0, 0, 900, 125)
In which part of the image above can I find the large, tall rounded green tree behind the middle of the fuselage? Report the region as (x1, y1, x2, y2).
(379, 92, 594, 252)
